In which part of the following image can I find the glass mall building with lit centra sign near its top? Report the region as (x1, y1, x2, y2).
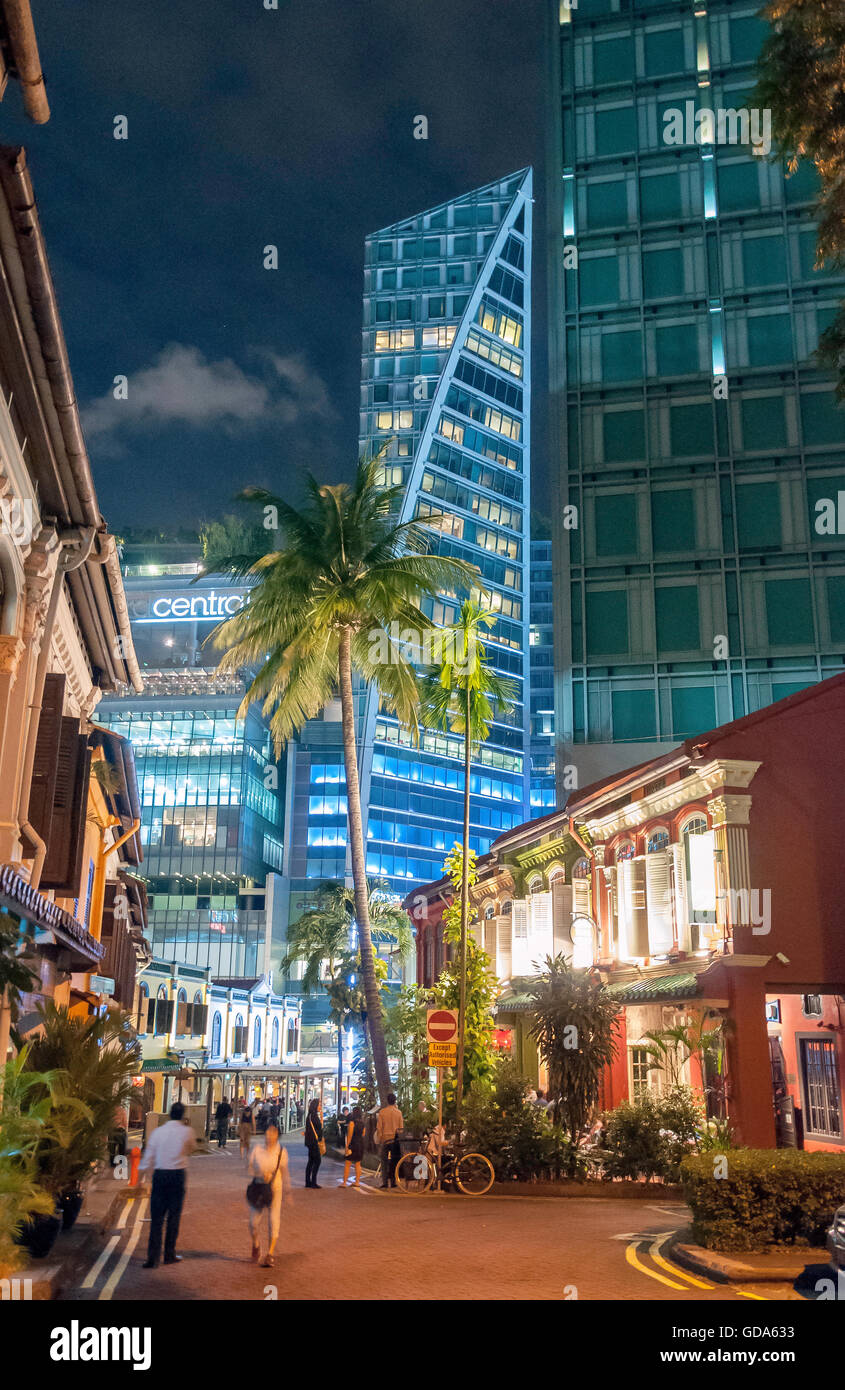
(97, 545, 288, 976)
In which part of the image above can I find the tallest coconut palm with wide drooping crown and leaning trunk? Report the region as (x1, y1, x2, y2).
(207, 459, 478, 1101)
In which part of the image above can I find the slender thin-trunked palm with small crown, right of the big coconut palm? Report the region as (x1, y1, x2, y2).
(420, 598, 517, 1127)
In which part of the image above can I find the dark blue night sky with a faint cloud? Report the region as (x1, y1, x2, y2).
(0, 0, 545, 532)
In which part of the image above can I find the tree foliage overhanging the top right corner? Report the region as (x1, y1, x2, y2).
(749, 0, 845, 400)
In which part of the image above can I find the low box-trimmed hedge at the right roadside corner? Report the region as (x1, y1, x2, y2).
(681, 1148, 845, 1250)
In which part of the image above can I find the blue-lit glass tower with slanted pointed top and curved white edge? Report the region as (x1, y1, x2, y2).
(360, 170, 532, 892)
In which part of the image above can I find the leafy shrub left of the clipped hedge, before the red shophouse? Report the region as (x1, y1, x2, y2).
(602, 1086, 705, 1183)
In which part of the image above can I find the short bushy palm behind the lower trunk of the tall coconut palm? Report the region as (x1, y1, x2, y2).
(281, 878, 413, 1113)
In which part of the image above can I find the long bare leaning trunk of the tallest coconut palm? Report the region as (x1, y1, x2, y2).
(338, 627, 391, 1105)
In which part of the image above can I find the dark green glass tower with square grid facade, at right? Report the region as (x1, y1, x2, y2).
(549, 0, 845, 785)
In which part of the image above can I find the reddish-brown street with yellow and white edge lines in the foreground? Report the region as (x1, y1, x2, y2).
(63, 1137, 799, 1302)
